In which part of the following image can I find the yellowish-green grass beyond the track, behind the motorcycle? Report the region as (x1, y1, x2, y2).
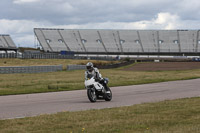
(0, 59, 200, 95)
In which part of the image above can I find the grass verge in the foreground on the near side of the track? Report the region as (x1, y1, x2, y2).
(0, 97, 200, 133)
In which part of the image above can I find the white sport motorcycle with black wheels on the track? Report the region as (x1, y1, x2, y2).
(85, 77, 112, 102)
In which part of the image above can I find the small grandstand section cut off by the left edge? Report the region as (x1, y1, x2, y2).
(0, 34, 17, 52)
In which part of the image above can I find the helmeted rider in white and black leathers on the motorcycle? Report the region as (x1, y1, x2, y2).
(85, 62, 109, 93)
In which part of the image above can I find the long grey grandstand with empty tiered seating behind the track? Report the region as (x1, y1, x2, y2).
(34, 28, 200, 55)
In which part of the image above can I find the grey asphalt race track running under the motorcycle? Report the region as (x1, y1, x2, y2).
(0, 79, 200, 119)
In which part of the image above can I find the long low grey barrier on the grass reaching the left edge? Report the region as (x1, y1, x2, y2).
(0, 65, 62, 74)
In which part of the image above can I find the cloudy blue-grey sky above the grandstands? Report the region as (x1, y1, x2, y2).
(0, 0, 200, 47)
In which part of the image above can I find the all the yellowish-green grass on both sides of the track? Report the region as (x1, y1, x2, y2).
(0, 59, 200, 133)
